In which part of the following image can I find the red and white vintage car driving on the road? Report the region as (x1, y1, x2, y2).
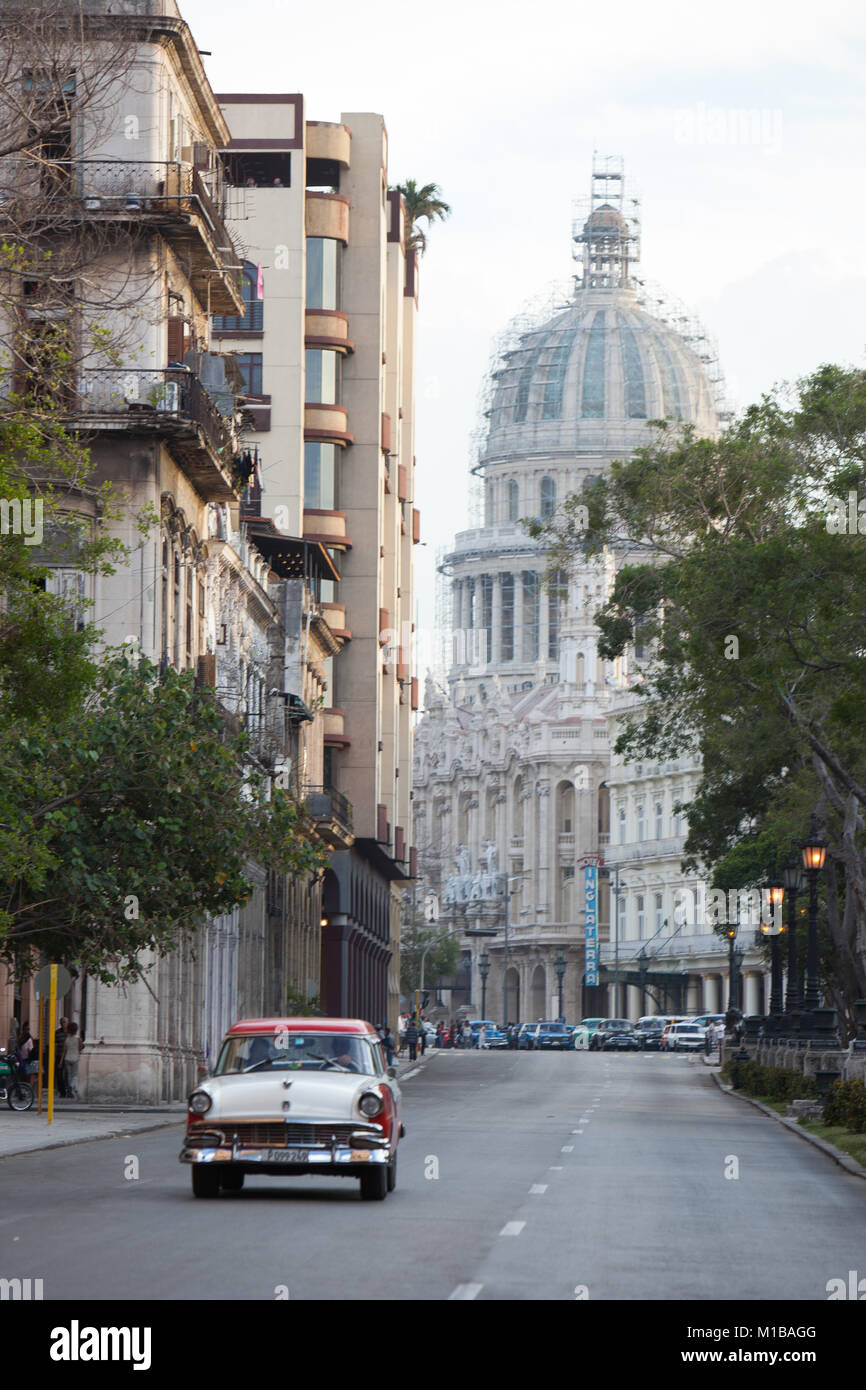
(181, 1019, 405, 1201)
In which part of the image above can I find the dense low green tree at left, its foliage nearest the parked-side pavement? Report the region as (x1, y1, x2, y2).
(0, 653, 327, 983)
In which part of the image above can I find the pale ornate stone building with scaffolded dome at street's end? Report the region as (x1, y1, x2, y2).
(413, 160, 772, 1022)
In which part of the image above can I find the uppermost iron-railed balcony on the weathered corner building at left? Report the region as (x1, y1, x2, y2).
(11, 158, 243, 314)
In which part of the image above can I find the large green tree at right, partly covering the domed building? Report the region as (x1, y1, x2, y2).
(530, 366, 866, 1023)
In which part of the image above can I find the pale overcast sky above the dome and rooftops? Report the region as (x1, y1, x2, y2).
(179, 0, 866, 639)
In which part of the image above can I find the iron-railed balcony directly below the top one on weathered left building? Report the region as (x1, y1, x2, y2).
(71, 367, 243, 502)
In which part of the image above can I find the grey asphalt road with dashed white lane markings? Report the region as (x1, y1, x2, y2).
(0, 1052, 866, 1301)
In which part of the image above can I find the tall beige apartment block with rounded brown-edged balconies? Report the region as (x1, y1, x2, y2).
(214, 93, 420, 1022)
